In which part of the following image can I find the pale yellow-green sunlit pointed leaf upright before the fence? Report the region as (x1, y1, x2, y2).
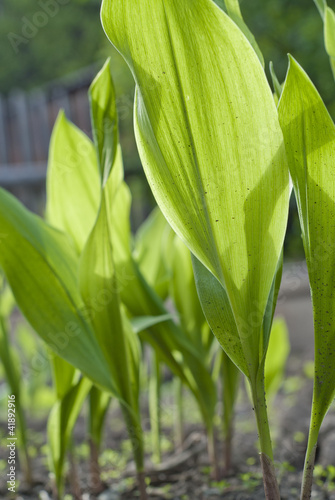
(46, 112, 100, 253)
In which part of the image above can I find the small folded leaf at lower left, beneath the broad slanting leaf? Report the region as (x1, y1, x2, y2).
(47, 377, 92, 497)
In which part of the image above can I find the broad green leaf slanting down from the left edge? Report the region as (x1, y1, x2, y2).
(0, 189, 114, 391)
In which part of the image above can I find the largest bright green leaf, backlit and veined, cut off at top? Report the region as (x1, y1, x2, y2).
(102, 0, 288, 382)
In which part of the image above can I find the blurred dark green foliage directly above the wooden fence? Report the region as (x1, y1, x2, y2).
(0, 0, 105, 93)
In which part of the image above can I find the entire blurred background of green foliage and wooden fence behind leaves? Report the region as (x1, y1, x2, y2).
(0, 0, 335, 260)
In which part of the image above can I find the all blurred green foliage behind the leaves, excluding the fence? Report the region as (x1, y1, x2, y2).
(0, 0, 335, 248)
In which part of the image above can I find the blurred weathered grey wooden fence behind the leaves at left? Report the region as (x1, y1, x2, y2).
(0, 63, 96, 187)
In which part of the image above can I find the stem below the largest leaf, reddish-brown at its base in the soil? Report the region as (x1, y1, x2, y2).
(251, 373, 280, 500)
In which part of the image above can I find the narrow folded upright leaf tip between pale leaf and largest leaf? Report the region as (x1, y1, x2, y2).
(88, 59, 119, 186)
